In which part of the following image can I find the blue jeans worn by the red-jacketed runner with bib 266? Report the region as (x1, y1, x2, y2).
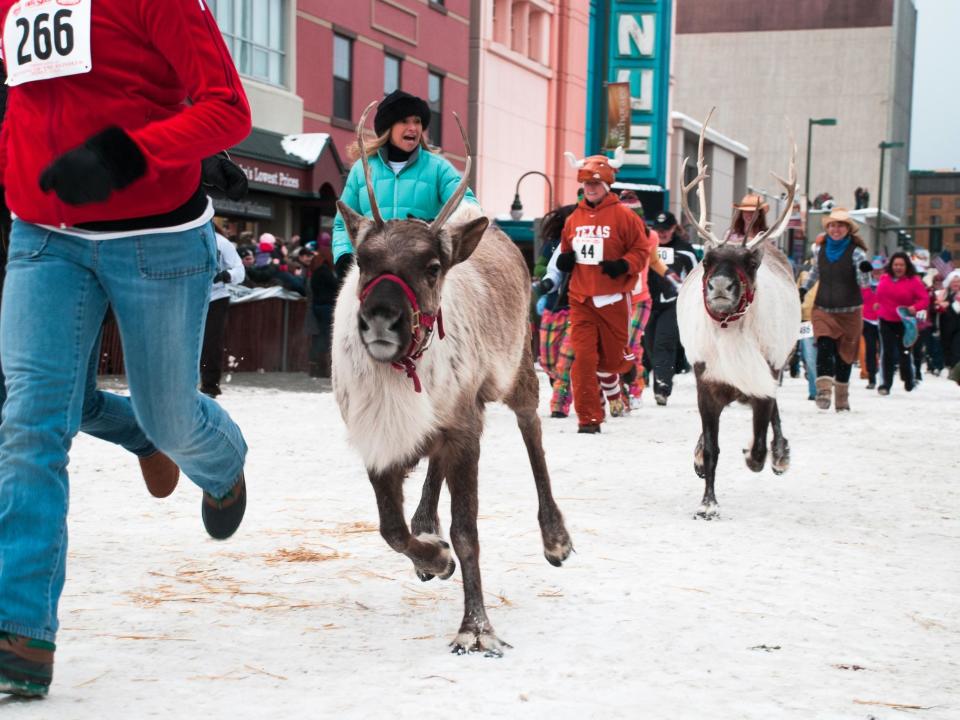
(0, 221, 247, 642)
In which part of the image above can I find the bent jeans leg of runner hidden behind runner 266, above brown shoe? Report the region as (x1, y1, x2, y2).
(0, 328, 157, 457)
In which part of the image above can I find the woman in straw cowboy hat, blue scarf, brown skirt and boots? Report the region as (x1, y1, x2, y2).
(801, 208, 872, 412)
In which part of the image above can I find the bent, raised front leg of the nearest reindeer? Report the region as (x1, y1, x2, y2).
(368, 466, 457, 580)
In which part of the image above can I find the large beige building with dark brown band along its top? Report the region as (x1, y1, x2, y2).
(672, 0, 917, 238)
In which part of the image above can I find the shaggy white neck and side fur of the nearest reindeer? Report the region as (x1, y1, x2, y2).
(333, 246, 526, 471)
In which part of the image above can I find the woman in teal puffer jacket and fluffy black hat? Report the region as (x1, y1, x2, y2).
(333, 90, 479, 277)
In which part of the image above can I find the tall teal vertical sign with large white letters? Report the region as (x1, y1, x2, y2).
(598, 0, 672, 186)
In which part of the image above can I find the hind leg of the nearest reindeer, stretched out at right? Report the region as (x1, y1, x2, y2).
(505, 358, 573, 567)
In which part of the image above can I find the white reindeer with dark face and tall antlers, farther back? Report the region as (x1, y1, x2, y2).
(677, 110, 800, 519)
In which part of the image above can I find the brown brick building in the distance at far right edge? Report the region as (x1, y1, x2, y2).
(909, 170, 960, 260)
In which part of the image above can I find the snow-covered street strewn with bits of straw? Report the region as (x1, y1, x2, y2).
(0, 375, 960, 720)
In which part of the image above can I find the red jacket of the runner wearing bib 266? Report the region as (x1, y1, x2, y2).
(0, 0, 250, 227)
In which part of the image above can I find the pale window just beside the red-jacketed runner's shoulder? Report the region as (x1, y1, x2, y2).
(209, 0, 287, 87)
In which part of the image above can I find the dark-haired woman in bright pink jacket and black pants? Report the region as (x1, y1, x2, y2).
(876, 252, 930, 395)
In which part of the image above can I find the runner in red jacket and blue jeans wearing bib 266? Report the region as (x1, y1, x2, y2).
(0, 0, 250, 696)
